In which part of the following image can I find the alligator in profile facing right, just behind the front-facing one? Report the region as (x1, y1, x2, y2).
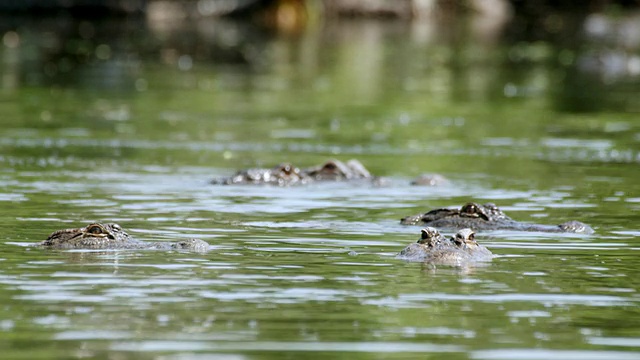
(400, 202, 594, 234)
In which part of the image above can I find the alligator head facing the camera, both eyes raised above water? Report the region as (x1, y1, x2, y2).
(396, 227, 493, 266)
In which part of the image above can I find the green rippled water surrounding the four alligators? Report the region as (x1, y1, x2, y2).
(0, 11, 640, 359)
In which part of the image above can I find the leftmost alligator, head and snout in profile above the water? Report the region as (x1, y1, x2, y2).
(38, 223, 209, 252)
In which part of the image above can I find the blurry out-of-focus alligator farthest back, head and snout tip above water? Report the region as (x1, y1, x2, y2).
(211, 159, 448, 186)
